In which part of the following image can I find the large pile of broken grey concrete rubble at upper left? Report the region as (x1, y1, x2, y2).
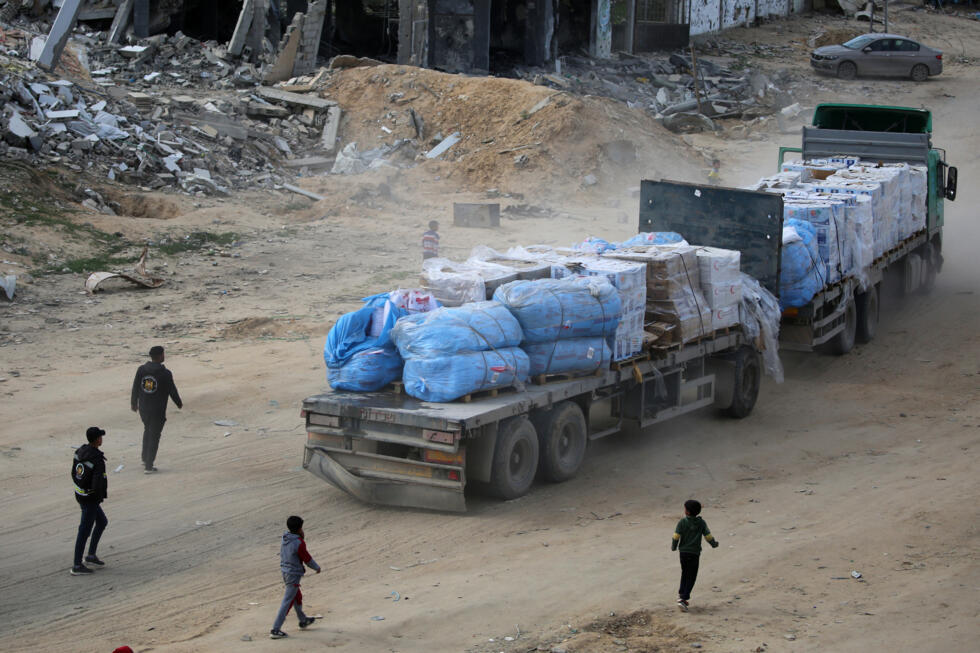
(0, 25, 352, 202)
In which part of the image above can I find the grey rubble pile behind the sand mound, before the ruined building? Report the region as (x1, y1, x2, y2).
(515, 43, 795, 132)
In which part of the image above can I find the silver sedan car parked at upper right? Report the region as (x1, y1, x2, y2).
(810, 34, 943, 82)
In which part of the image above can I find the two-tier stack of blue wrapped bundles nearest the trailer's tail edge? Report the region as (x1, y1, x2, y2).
(391, 301, 528, 402)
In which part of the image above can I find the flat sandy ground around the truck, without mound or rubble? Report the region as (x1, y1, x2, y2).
(0, 6, 980, 652)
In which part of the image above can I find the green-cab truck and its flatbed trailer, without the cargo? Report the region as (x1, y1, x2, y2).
(301, 105, 956, 511)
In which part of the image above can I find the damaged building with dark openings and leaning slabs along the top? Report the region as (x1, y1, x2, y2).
(26, 0, 811, 76)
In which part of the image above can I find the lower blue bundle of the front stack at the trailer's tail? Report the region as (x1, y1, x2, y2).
(402, 347, 528, 402)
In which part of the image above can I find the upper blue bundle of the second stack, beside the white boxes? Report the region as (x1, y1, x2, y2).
(493, 277, 622, 344)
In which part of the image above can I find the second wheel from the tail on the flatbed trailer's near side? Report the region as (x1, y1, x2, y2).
(531, 401, 588, 483)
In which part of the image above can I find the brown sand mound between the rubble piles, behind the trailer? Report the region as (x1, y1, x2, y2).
(323, 65, 704, 200)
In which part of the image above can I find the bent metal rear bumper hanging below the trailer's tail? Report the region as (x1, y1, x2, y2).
(303, 444, 466, 512)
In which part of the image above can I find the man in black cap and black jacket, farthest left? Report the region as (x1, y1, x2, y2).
(71, 426, 109, 576)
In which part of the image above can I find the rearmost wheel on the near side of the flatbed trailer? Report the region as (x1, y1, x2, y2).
(488, 417, 538, 499)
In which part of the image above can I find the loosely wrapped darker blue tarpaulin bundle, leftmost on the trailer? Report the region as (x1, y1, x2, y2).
(323, 293, 408, 392)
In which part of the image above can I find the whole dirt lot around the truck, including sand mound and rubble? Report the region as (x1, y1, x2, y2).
(0, 6, 980, 653)
